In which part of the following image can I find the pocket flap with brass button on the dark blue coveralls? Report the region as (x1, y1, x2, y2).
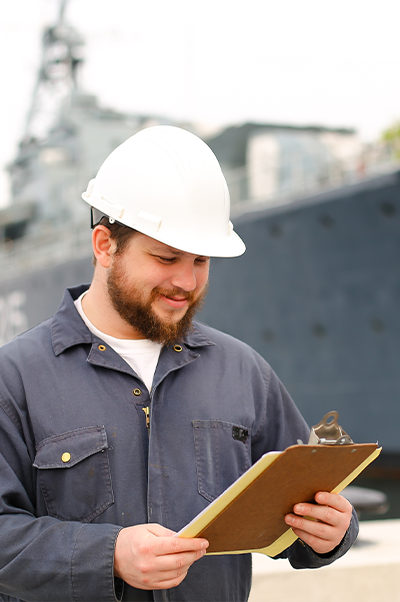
(33, 426, 108, 469)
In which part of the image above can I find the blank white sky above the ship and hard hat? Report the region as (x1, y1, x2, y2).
(0, 0, 400, 206)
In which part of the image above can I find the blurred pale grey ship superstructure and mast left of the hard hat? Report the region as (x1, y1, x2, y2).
(0, 0, 172, 270)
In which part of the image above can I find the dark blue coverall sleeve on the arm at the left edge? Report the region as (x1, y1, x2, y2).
(0, 398, 121, 602)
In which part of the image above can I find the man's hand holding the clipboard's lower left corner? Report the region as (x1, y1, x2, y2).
(114, 524, 208, 590)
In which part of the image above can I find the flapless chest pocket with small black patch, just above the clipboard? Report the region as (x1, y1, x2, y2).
(192, 420, 251, 502)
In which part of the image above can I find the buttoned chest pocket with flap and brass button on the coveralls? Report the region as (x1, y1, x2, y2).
(33, 426, 114, 522)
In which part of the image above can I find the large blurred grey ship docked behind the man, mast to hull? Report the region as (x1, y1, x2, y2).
(0, 0, 400, 464)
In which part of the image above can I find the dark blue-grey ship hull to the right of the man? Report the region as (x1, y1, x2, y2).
(202, 172, 400, 453)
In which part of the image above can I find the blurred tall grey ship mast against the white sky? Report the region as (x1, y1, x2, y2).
(21, 0, 83, 146)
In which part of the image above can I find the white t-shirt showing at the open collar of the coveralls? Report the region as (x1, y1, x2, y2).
(75, 291, 162, 391)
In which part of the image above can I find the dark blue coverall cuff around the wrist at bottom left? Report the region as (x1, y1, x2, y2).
(71, 523, 123, 602)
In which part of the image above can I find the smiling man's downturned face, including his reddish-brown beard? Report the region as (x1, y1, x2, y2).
(107, 233, 209, 345)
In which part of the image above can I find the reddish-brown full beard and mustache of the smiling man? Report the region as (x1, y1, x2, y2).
(107, 261, 207, 346)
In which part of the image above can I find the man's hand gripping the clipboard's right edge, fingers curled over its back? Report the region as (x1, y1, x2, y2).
(285, 491, 352, 554)
